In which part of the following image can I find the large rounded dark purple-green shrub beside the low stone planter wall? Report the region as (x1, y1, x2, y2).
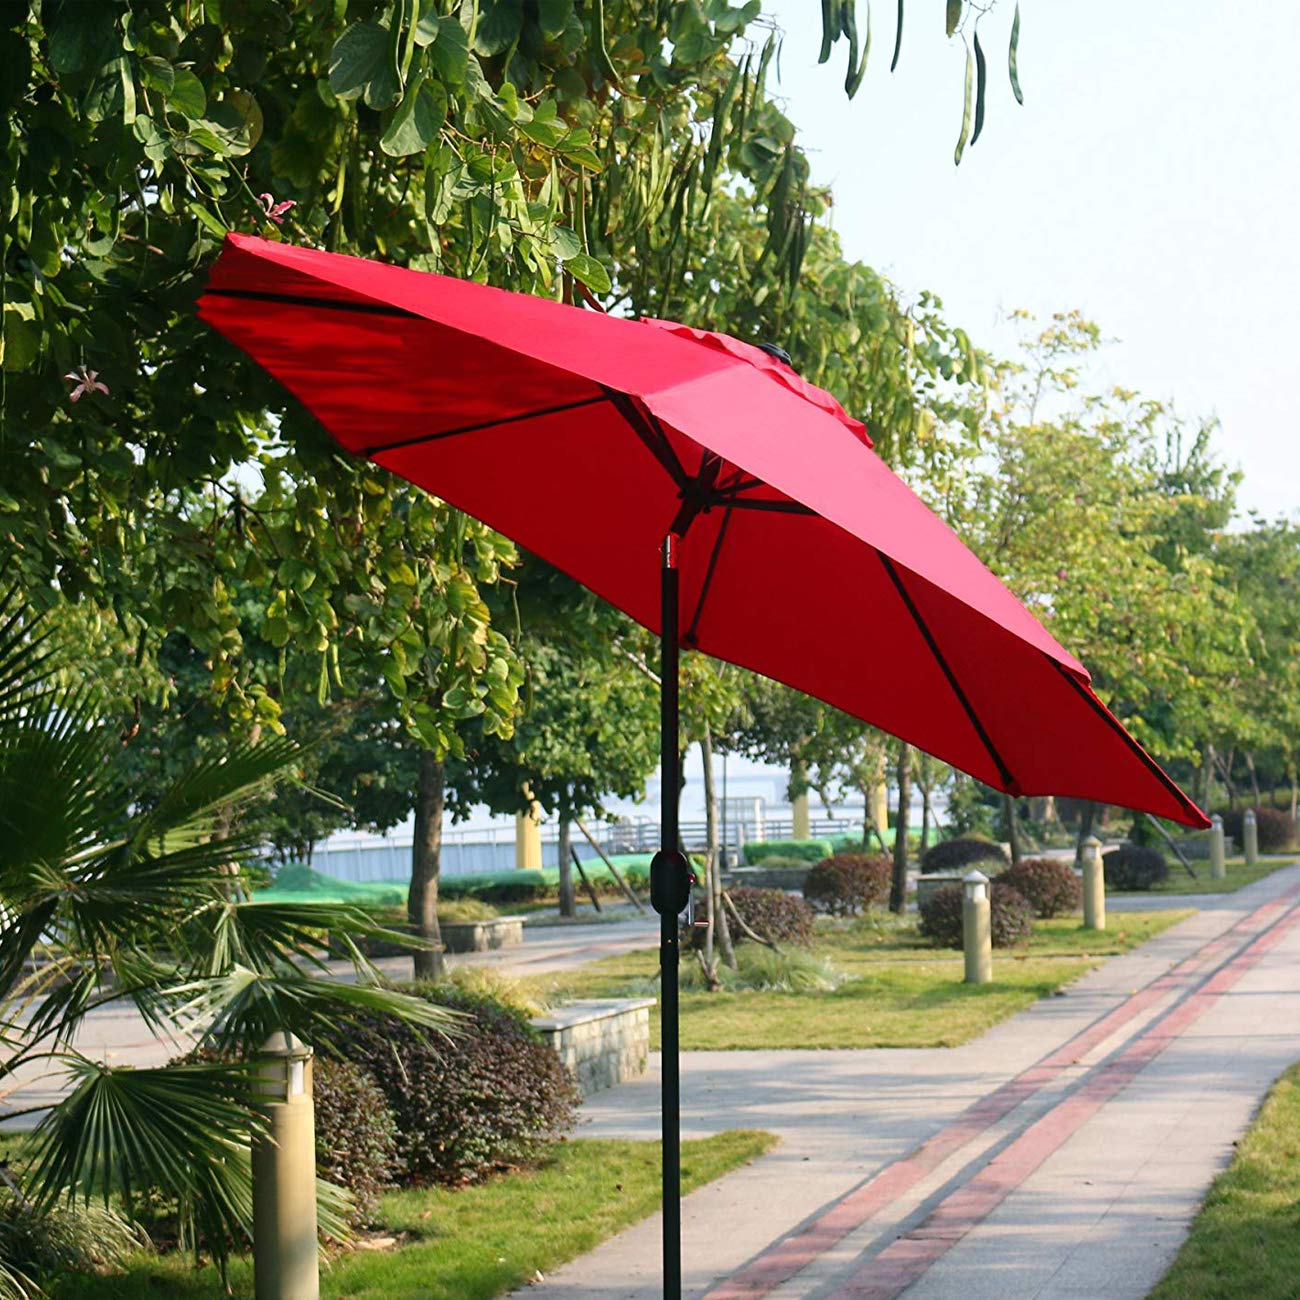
(341, 984, 579, 1186)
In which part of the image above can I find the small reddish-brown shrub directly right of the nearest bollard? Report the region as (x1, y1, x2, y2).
(312, 1057, 398, 1223)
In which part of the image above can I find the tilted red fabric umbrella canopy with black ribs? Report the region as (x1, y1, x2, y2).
(199, 235, 1208, 826)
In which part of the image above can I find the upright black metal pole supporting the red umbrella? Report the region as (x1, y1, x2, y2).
(659, 533, 681, 1300)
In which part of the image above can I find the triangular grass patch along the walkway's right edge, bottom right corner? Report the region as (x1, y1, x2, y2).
(1149, 1066, 1300, 1300)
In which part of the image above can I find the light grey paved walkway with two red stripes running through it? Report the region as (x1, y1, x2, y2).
(514, 867, 1300, 1300)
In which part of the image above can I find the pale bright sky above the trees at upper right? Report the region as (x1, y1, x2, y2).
(764, 0, 1300, 516)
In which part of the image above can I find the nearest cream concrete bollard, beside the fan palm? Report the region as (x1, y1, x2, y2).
(252, 1032, 321, 1300)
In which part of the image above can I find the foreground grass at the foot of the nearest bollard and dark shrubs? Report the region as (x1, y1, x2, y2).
(51, 1130, 776, 1300)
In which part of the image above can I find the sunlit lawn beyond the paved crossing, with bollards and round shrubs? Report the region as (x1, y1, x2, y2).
(520, 910, 1192, 1052)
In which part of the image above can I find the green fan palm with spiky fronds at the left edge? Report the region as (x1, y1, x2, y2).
(0, 593, 455, 1296)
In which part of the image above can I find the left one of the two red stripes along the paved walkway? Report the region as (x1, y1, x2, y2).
(706, 885, 1300, 1300)
